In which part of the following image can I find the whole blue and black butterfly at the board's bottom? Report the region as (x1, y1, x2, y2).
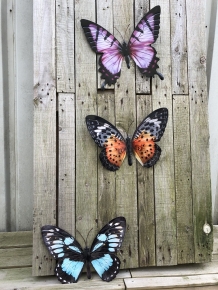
(41, 216, 126, 284)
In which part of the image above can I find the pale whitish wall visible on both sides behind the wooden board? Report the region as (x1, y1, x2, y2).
(0, 0, 218, 231)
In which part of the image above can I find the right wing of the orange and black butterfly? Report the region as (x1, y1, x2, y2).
(132, 108, 168, 167)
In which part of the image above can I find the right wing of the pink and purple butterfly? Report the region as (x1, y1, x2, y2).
(128, 6, 163, 79)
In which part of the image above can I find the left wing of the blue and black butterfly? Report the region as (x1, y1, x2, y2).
(41, 225, 85, 284)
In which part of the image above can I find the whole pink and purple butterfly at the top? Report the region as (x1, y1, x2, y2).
(81, 6, 164, 88)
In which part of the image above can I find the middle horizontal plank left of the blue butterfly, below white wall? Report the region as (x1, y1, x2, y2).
(0, 247, 33, 268)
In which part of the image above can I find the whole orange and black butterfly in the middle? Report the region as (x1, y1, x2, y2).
(86, 108, 168, 171)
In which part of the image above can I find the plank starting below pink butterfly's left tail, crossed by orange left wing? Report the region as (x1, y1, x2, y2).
(98, 90, 117, 225)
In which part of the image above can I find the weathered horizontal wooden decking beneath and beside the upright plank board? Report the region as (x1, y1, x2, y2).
(0, 226, 218, 290)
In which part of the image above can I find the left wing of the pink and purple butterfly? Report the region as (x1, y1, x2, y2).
(81, 19, 123, 86)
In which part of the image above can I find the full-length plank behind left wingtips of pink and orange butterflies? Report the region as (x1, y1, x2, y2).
(75, 0, 98, 245)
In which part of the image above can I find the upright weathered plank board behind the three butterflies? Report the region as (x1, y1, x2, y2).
(33, 0, 212, 275)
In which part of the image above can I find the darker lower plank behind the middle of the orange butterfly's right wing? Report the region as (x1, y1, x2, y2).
(136, 95, 156, 267)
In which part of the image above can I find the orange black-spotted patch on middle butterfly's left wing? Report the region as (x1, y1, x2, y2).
(104, 135, 126, 167)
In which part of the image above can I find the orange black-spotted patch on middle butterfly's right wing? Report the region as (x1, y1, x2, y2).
(132, 132, 155, 166)
